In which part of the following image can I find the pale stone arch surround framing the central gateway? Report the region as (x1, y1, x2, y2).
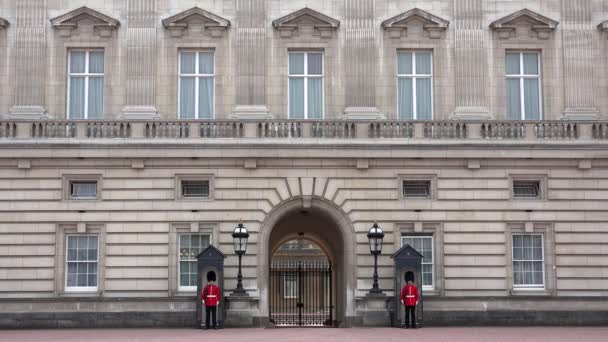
(257, 196, 357, 326)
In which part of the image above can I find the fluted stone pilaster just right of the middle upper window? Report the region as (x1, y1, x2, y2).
(343, 0, 382, 119)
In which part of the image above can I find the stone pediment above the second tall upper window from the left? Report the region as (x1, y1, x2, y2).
(163, 7, 230, 38)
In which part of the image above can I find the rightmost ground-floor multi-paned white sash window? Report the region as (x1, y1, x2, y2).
(513, 234, 545, 288)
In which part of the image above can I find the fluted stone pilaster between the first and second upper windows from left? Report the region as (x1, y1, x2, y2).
(122, 0, 158, 119)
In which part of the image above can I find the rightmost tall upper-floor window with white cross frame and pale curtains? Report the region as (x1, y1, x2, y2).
(505, 52, 542, 120)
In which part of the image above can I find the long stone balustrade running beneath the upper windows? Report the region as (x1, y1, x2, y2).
(0, 120, 608, 141)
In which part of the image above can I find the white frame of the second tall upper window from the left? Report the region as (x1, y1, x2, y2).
(177, 50, 216, 120)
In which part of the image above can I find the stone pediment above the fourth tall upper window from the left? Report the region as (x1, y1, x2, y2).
(382, 8, 450, 39)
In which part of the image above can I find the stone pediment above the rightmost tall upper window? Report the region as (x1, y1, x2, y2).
(490, 8, 559, 39)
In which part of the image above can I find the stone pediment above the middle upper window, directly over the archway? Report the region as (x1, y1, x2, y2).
(272, 7, 340, 38)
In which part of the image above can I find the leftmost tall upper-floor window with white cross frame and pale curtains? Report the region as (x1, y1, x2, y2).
(68, 50, 104, 119)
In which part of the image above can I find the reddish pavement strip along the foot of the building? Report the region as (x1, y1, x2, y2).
(0, 327, 608, 342)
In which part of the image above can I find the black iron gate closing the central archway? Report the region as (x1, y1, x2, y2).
(269, 259, 333, 327)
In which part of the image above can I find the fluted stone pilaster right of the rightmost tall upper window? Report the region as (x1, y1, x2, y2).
(562, 0, 598, 120)
